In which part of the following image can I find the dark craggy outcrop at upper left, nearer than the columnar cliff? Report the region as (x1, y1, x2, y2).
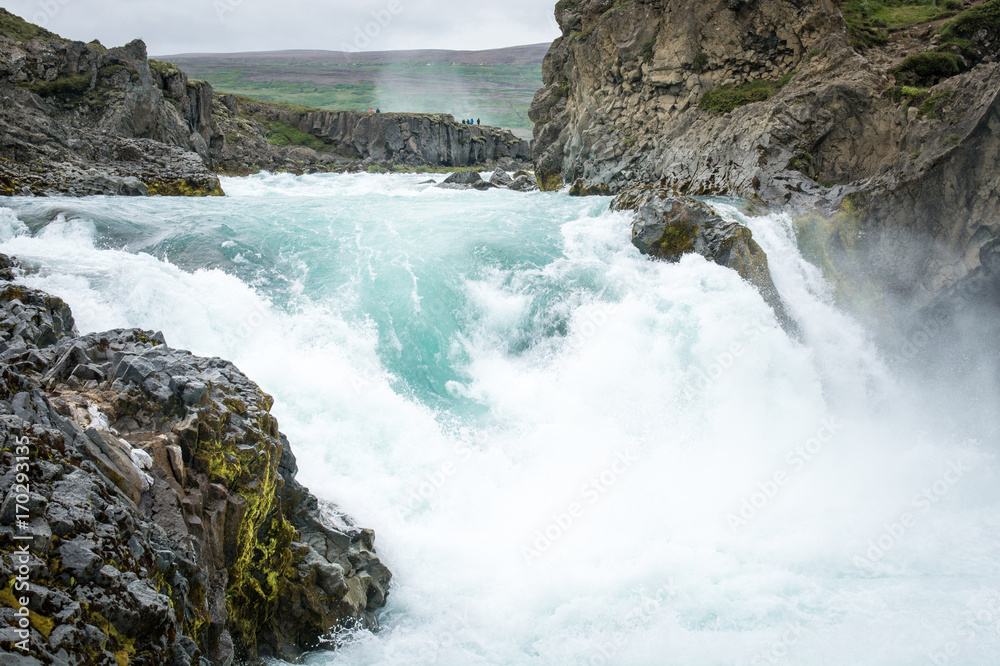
(0, 10, 221, 195)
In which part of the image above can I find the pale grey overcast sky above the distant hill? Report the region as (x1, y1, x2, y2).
(0, 0, 559, 55)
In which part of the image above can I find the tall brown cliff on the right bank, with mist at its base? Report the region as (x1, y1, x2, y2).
(531, 0, 1000, 335)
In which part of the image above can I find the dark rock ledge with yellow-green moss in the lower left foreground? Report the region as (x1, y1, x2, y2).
(0, 257, 391, 666)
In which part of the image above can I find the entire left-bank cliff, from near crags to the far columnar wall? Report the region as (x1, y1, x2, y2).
(0, 8, 531, 196)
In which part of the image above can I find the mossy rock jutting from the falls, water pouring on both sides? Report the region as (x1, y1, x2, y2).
(611, 186, 796, 332)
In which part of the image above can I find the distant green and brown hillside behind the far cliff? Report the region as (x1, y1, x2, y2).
(158, 44, 549, 137)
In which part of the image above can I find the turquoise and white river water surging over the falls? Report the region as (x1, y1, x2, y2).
(0, 175, 1000, 666)
